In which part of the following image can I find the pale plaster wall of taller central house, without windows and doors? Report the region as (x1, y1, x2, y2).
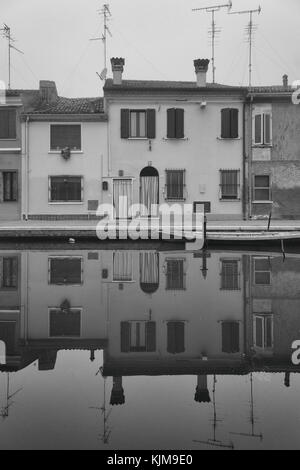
(103, 91, 243, 219)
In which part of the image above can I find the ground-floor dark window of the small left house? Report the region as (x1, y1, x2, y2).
(49, 176, 83, 202)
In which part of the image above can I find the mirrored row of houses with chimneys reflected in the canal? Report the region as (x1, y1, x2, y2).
(0, 249, 300, 405)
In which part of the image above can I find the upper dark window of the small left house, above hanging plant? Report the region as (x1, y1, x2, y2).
(50, 124, 81, 151)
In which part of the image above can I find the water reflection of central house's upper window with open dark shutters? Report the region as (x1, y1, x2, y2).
(121, 321, 156, 353)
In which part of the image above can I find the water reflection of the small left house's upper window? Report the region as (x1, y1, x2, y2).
(50, 308, 81, 338)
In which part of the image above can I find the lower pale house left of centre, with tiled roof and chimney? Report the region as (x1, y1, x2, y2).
(22, 82, 107, 220)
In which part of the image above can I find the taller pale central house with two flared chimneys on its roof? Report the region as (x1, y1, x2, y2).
(103, 59, 246, 219)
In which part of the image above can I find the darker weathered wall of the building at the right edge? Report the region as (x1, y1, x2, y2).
(249, 99, 300, 219)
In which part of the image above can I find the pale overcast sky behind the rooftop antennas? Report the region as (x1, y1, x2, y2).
(0, 0, 300, 97)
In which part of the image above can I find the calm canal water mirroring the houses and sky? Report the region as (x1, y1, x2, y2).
(0, 245, 300, 450)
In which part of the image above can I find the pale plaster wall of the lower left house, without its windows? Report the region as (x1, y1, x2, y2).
(22, 116, 107, 219)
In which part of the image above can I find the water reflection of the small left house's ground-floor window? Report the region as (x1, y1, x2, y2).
(49, 258, 82, 285)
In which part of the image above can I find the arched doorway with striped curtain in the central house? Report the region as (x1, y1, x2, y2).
(140, 166, 159, 217)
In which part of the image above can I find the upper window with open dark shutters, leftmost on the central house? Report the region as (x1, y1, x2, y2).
(121, 109, 156, 139)
